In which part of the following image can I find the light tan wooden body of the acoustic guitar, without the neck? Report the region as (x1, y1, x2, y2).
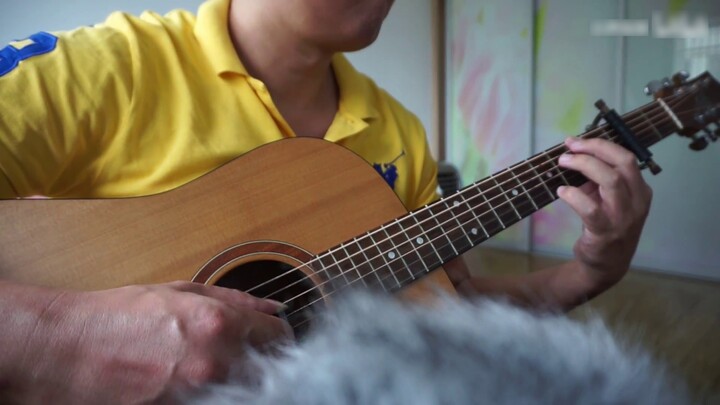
(0, 138, 452, 302)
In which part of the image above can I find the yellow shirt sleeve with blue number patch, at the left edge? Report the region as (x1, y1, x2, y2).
(0, 26, 132, 198)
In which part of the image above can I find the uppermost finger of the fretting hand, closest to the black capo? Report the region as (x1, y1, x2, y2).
(565, 138, 642, 182)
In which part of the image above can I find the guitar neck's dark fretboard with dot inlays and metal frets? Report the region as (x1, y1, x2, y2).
(318, 100, 680, 292)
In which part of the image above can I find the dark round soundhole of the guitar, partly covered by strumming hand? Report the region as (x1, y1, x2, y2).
(215, 260, 323, 337)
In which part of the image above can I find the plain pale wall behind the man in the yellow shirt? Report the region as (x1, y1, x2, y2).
(0, 0, 437, 151)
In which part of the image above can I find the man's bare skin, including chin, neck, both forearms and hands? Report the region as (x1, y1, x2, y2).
(0, 0, 652, 403)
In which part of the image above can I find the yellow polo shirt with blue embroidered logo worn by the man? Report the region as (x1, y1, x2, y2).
(0, 0, 437, 209)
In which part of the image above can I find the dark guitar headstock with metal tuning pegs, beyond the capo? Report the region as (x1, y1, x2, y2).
(645, 72, 720, 150)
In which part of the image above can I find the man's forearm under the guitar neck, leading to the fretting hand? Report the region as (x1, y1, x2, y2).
(456, 261, 614, 311)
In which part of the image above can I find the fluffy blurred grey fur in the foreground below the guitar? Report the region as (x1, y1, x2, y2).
(191, 293, 689, 405)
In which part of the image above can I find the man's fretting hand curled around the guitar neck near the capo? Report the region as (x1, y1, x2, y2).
(558, 138, 652, 288)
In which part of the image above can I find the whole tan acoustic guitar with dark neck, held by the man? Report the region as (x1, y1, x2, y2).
(0, 73, 720, 330)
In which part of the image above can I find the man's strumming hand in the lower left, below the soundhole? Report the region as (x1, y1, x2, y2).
(14, 282, 291, 403)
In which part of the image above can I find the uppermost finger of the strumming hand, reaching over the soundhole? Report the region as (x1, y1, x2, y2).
(170, 281, 286, 314)
